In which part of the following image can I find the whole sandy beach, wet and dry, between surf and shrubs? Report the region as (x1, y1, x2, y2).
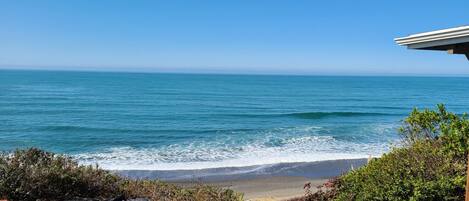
(116, 159, 367, 200)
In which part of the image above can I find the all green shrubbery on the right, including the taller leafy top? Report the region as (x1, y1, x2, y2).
(296, 105, 469, 201)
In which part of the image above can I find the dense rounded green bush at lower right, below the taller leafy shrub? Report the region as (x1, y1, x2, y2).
(336, 141, 466, 200)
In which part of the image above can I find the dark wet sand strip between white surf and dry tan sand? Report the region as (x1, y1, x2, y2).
(112, 158, 368, 182)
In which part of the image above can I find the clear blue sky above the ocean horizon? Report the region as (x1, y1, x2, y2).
(0, 0, 469, 75)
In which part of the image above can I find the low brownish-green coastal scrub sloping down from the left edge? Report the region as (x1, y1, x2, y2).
(0, 148, 243, 201)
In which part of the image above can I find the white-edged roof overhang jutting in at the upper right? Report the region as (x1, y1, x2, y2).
(394, 26, 469, 59)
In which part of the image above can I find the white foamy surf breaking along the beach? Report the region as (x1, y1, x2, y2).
(75, 127, 389, 170)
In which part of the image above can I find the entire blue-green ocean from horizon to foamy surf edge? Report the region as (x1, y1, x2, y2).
(0, 70, 469, 170)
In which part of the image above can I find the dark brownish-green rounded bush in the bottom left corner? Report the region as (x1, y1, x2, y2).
(0, 148, 120, 201)
